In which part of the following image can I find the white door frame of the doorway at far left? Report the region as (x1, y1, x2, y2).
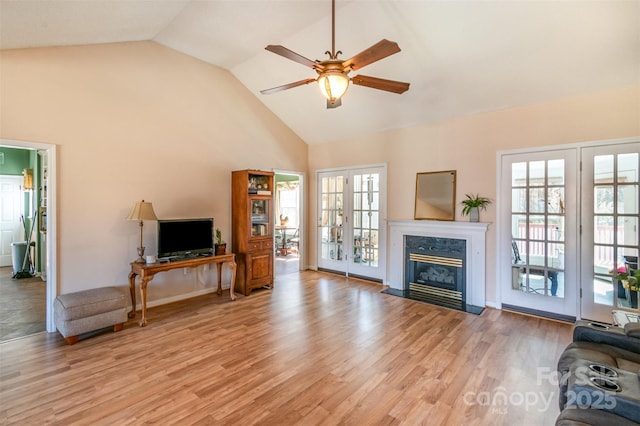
(0, 139, 58, 333)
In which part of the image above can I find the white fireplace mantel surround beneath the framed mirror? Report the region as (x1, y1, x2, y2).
(387, 220, 489, 307)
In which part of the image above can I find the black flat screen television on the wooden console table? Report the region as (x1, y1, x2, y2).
(158, 218, 214, 258)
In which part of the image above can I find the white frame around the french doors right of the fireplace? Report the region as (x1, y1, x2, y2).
(495, 135, 640, 319)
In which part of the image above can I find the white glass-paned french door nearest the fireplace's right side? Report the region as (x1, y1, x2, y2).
(499, 149, 578, 318)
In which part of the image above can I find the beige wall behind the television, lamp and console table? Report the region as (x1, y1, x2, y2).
(0, 42, 307, 301)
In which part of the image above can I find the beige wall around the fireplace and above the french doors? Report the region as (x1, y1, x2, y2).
(309, 86, 640, 302)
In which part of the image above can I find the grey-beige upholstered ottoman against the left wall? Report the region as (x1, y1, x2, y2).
(53, 287, 129, 345)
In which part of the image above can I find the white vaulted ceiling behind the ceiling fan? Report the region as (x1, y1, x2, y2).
(0, 0, 640, 144)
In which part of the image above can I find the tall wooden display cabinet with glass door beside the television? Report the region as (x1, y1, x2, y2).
(231, 170, 275, 296)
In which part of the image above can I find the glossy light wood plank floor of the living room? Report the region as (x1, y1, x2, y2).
(0, 271, 571, 425)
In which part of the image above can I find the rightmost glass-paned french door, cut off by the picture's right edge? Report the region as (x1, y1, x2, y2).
(581, 143, 640, 323)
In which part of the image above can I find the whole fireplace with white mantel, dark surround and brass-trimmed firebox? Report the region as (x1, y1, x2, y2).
(384, 221, 487, 314)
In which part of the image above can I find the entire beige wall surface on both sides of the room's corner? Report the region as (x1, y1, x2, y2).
(0, 38, 640, 308)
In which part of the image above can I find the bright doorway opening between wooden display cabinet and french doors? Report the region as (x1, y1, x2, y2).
(273, 171, 304, 276)
